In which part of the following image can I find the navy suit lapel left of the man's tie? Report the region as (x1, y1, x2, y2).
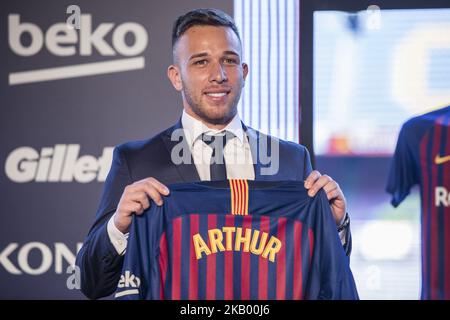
(161, 119, 200, 182)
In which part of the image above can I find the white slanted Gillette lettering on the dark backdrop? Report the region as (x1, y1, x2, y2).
(5, 144, 114, 183)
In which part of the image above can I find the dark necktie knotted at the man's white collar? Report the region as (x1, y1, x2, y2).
(202, 131, 234, 180)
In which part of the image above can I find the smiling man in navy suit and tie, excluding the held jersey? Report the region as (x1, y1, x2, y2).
(76, 9, 351, 299)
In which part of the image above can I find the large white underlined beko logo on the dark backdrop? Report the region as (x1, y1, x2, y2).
(8, 14, 148, 85)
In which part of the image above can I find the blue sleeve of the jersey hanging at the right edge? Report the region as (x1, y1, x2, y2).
(386, 122, 419, 207)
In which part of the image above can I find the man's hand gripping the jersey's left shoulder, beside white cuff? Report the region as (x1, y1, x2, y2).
(114, 177, 169, 233)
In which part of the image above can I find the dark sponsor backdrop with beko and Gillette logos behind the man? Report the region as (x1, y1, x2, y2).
(0, 0, 233, 299)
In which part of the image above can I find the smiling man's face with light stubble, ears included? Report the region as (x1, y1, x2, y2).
(168, 26, 248, 125)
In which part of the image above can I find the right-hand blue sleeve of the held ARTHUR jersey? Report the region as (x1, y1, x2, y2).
(306, 191, 359, 300)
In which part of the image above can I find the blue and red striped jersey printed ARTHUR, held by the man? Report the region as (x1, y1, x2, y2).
(115, 180, 358, 300)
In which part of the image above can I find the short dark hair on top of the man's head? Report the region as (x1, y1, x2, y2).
(172, 8, 241, 48)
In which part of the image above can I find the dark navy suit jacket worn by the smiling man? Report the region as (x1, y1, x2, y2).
(76, 121, 351, 299)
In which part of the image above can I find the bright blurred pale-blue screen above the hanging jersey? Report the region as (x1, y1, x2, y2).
(313, 6, 450, 156)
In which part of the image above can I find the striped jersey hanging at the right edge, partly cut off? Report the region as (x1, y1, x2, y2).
(386, 106, 450, 299)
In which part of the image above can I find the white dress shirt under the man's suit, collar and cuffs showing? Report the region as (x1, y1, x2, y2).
(107, 111, 346, 254)
